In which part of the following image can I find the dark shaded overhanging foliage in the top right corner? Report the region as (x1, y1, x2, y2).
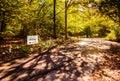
(98, 0, 120, 23)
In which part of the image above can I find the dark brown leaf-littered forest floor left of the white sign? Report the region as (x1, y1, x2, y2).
(0, 38, 26, 64)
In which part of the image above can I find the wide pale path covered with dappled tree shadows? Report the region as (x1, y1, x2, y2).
(0, 38, 120, 81)
